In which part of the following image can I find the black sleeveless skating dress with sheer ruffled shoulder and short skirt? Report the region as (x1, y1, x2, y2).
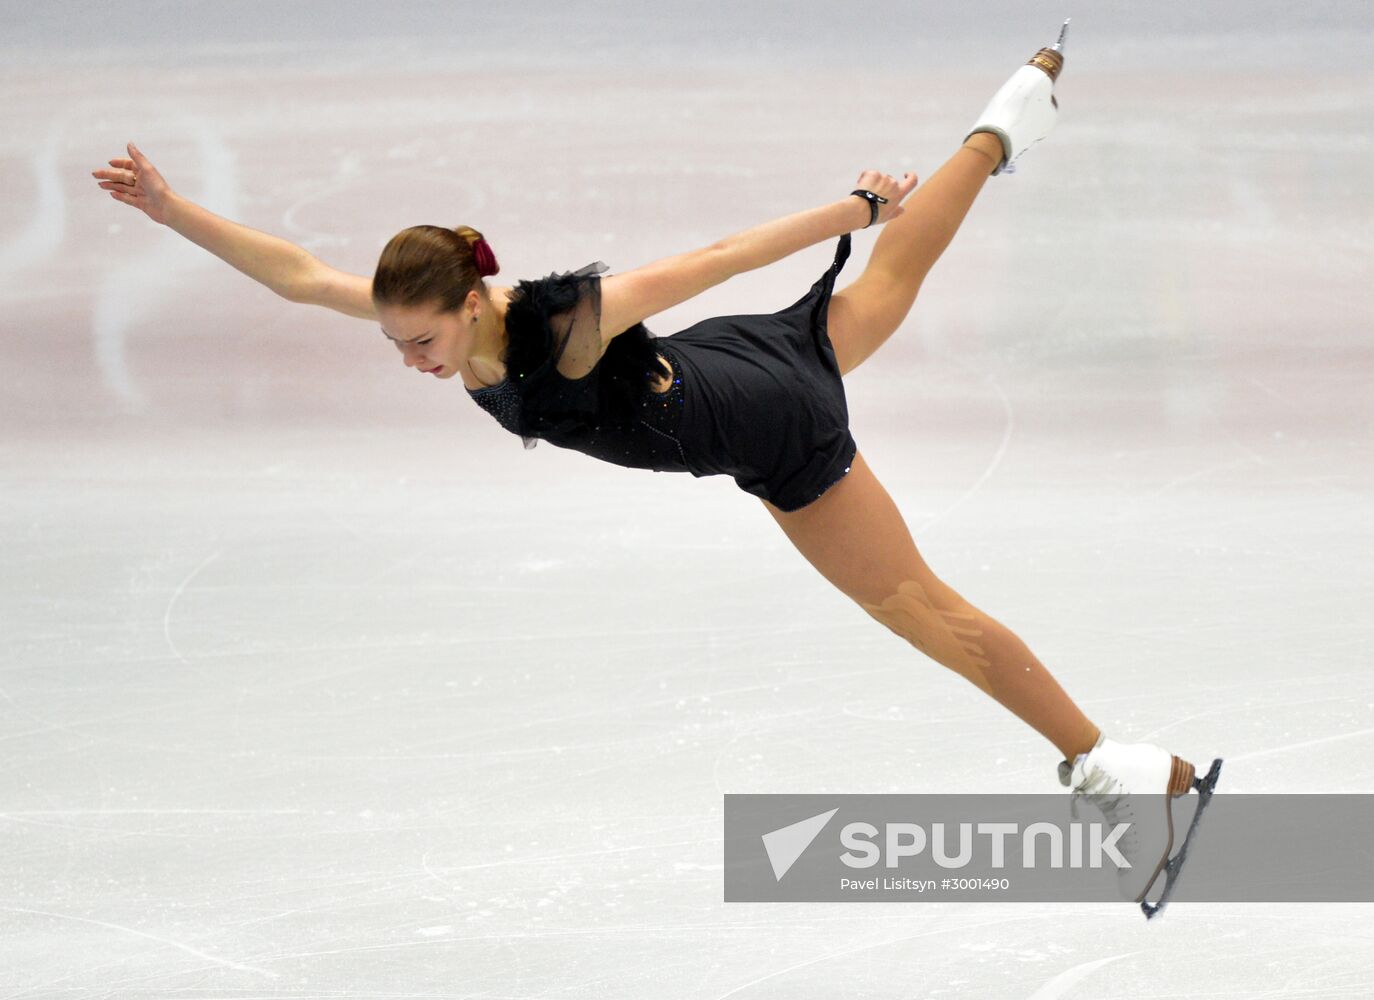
(469, 234, 856, 511)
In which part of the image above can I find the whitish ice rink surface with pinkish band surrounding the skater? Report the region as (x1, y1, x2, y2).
(0, 0, 1374, 1000)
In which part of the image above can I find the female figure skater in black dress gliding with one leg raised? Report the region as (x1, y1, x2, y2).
(93, 36, 1215, 912)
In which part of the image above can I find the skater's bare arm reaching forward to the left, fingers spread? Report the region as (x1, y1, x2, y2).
(91, 143, 376, 320)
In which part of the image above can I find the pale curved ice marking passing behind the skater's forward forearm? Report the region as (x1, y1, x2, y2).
(91, 121, 238, 409)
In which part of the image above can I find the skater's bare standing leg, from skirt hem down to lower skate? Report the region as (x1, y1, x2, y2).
(764, 450, 1098, 761)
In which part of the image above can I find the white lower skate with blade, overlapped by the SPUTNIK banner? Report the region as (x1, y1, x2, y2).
(1059, 736, 1221, 918)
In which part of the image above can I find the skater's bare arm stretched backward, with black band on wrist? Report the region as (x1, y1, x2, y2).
(600, 170, 916, 341)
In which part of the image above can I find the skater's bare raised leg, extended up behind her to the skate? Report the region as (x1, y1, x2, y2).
(827, 132, 1002, 375)
